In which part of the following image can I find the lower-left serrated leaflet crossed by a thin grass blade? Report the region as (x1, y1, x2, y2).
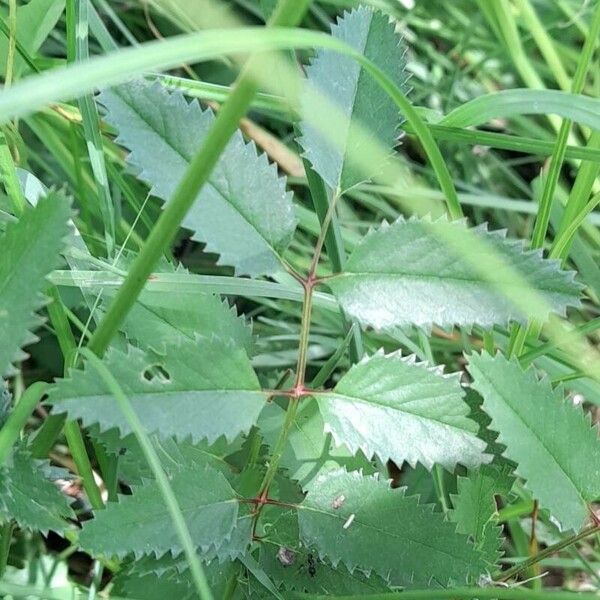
(79, 464, 238, 557)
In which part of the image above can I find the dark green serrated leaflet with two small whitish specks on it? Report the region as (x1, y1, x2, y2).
(299, 470, 484, 587)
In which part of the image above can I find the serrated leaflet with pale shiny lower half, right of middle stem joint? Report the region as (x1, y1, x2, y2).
(315, 351, 487, 469)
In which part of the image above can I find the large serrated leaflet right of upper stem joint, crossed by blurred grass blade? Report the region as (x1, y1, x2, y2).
(326, 217, 580, 329)
